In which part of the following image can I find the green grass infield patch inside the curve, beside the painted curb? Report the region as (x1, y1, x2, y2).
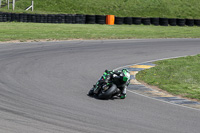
(136, 54, 200, 101)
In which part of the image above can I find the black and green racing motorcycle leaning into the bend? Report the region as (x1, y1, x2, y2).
(88, 73, 120, 99)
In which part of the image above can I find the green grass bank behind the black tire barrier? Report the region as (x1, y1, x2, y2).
(0, 0, 200, 18)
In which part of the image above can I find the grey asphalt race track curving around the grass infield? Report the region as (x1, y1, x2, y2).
(0, 39, 200, 133)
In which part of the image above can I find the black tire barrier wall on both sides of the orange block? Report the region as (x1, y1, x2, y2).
(0, 12, 200, 26)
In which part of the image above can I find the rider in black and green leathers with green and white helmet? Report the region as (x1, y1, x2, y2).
(88, 69, 130, 99)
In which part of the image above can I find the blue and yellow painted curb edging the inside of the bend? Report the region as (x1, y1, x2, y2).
(126, 62, 200, 110)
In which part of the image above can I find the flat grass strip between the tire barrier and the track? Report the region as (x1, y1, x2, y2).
(0, 22, 200, 41)
